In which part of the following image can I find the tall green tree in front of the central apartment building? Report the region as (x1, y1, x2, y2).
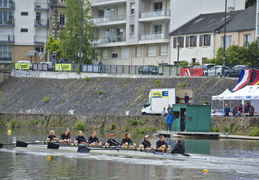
(60, 0, 97, 64)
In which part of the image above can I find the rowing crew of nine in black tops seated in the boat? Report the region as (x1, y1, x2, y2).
(47, 129, 185, 154)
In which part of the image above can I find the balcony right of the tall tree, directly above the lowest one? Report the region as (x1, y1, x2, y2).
(93, 15, 126, 26)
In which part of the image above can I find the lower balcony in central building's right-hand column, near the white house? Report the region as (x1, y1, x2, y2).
(140, 33, 169, 43)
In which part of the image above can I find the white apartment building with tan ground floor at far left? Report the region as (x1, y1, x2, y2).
(0, 0, 49, 62)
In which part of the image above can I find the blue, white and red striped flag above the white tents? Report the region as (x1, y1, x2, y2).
(232, 69, 253, 91)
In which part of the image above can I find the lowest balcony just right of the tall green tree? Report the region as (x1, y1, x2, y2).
(95, 36, 126, 47)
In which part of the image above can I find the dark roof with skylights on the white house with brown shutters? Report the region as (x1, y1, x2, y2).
(169, 11, 242, 36)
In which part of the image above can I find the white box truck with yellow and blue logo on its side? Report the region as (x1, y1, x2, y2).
(141, 88, 193, 115)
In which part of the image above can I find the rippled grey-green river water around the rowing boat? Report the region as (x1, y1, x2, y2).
(0, 128, 259, 180)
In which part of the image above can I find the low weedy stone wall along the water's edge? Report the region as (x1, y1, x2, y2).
(0, 114, 259, 136)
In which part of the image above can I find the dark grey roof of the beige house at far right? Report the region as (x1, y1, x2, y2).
(219, 6, 256, 32)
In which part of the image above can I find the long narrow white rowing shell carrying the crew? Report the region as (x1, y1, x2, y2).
(13, 144, 209, 161)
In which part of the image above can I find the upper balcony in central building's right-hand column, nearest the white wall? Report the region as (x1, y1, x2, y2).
(139, 10, 170, 22)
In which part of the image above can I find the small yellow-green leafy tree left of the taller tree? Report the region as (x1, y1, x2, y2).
(46, 36, 62, 59)
